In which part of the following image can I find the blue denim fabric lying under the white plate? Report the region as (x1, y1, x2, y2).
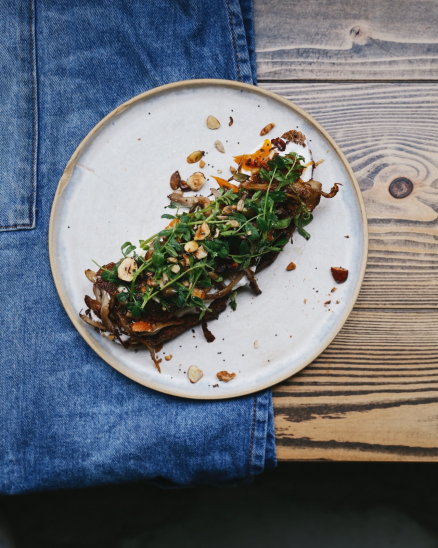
(0, 0, 275, 493)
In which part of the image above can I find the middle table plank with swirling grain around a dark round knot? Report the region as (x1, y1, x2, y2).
(263, 83, 438, 308)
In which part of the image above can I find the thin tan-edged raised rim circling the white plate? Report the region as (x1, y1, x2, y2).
(48, 78, 369, 400)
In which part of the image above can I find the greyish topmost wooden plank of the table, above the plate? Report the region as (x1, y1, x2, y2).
(254, 0, 438, 81)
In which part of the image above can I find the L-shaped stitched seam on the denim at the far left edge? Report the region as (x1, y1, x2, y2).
(0, 0, 37, 230)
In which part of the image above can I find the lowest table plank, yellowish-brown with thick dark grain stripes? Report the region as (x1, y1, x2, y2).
(274, 310, 438, 461)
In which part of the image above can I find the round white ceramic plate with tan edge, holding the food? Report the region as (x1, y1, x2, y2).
(49, 80, 368, 399)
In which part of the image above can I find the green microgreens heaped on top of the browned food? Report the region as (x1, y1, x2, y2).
(90, 153, 313, 319)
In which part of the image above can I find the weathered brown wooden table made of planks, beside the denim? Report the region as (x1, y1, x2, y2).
(254, 0, 438, 461)
